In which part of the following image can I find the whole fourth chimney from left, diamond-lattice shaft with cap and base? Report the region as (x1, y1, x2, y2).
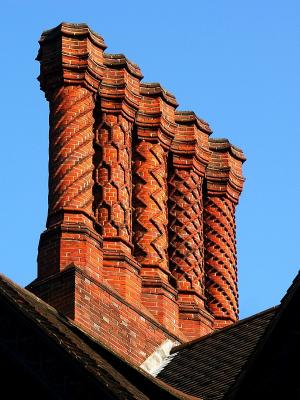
(168, 111, 213, 339)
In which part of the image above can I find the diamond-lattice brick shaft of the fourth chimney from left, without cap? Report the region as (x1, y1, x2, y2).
(168, 168, 204, 294)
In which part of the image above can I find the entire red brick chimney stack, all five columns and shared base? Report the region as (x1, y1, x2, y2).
(28, 23, 244, 365)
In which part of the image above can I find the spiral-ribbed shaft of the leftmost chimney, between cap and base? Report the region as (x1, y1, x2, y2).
(49, 86, 94, 213)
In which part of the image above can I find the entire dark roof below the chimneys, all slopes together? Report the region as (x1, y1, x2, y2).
(0, 268, 300, 400)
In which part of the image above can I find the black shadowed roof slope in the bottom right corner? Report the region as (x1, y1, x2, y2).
(226, 272, 300, 400)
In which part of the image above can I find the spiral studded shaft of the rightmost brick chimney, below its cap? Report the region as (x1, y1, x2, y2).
(204, 197, 238, 326)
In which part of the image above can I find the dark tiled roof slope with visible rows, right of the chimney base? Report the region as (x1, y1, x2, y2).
(158, 307, 277, 400)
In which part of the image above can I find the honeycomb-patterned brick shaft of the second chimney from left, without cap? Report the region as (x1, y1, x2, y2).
(94, 114, 132, 241)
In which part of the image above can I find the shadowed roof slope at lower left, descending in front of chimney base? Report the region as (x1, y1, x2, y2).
(0, 275, 198, 400)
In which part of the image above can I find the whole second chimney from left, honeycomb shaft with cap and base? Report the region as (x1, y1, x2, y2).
(94, 54, 142, 303)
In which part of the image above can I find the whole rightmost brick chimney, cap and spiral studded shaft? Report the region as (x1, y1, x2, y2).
(204, 139, 245, 328)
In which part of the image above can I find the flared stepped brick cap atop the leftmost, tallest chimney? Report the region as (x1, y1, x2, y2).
(37, 22, 106, 98)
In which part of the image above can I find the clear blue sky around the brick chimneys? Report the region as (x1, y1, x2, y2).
(0, 0, 300, 317)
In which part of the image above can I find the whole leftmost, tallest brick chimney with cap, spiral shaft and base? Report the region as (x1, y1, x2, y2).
(38, 23, 106, 279)
